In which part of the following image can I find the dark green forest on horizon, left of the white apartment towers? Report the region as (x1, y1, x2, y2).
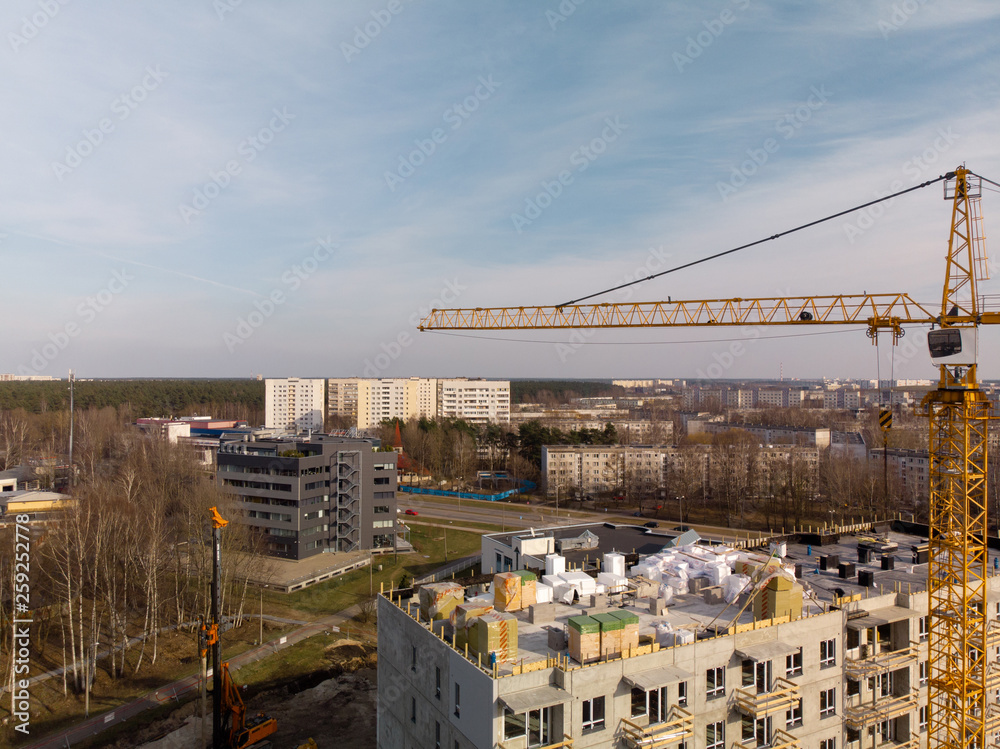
(0, 380, 264, 424)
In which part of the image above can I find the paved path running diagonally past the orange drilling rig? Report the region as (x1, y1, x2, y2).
(24, 606, 358, 749)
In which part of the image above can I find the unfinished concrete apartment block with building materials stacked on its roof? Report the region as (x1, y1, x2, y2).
(378, 522, 1000, 749)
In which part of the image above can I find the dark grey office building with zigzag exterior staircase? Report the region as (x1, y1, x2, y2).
(218, 435, 397, 559)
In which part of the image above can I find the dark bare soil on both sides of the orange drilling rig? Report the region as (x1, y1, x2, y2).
(106, 640, 377, 749)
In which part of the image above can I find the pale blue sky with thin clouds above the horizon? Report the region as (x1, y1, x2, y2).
(0, 0, 1000, 378)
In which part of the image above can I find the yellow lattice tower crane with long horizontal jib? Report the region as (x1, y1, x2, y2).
(419, 166, 1000, 749)
